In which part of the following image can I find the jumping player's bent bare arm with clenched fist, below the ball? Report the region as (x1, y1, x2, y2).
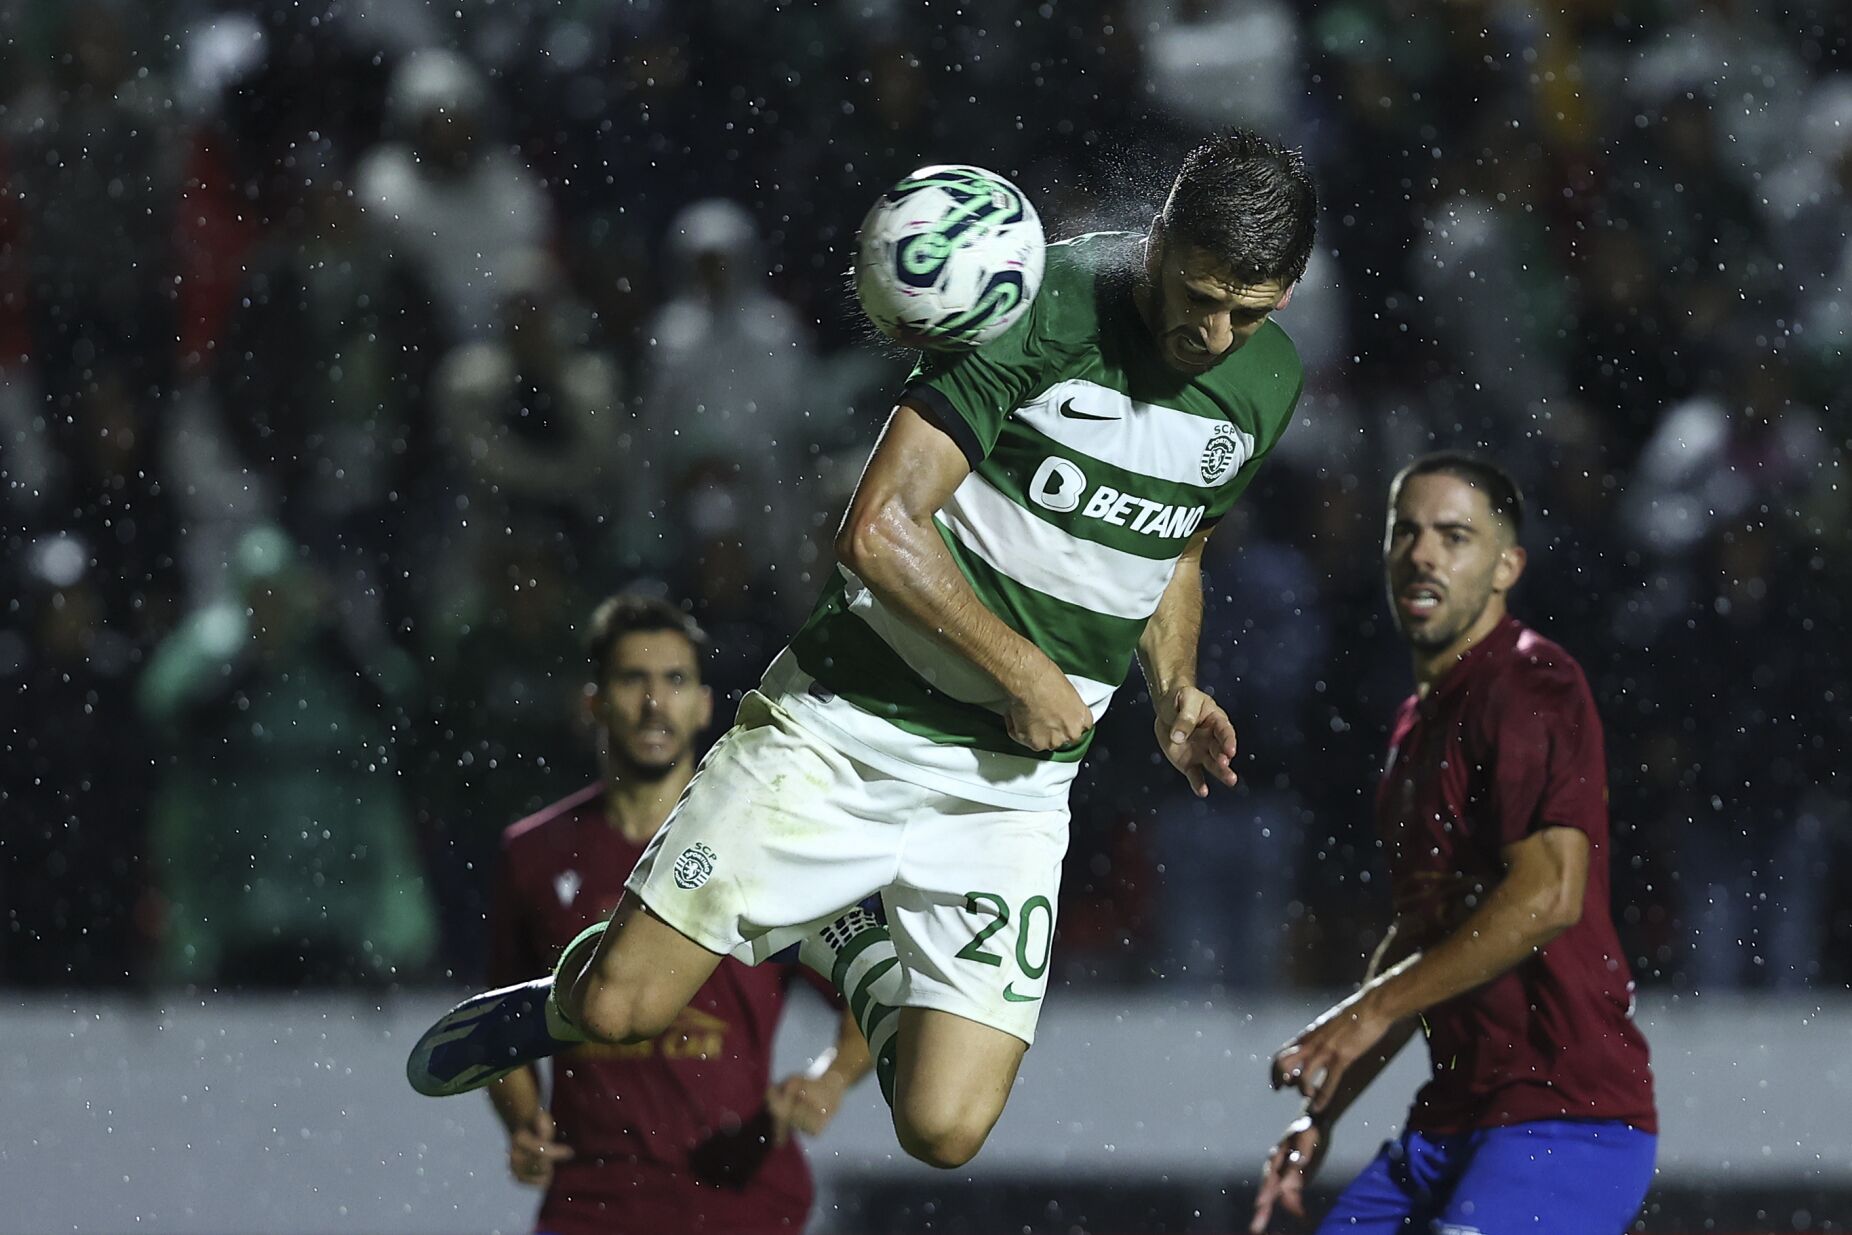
(835, 402, 1093, 750)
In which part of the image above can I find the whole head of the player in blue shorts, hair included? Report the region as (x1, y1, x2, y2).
(1383, 452, 1524, 652)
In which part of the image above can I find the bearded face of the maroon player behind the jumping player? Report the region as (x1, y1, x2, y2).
(593, 630, 713, 776)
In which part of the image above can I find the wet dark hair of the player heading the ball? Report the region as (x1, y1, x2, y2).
(1163, 128, 1319, 285)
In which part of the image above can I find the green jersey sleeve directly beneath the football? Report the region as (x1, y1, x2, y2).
(902, 287, 1050, 468)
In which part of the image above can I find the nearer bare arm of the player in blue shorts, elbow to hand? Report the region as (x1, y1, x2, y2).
(1272, 828, 1589, 1115)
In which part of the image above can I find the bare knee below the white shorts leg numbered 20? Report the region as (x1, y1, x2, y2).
(895, 1007, 1028, 1168)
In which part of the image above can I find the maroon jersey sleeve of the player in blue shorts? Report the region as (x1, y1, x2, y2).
(1485, 672, 1608, 846)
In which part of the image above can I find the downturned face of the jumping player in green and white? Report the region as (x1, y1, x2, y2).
(1150, 241, 1293, 374)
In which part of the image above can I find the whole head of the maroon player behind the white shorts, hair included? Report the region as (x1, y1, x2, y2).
(585, 593, 713, 780)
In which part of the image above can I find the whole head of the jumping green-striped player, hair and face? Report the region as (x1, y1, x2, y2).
(1145, 130, 1319, 374)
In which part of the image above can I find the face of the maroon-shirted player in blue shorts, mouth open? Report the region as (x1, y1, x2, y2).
(1383, 472, 1524, 652)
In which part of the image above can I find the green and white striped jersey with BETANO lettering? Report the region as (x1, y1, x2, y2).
(765, 231, 1304, 809)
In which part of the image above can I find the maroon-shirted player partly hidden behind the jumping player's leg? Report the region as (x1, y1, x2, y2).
(489, 596, 869, 1235)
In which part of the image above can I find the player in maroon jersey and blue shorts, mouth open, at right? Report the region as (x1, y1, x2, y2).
(1252, 454, 1658, 1235)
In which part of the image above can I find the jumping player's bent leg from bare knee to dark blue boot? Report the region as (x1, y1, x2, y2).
(406, 896, 720, 1098)
